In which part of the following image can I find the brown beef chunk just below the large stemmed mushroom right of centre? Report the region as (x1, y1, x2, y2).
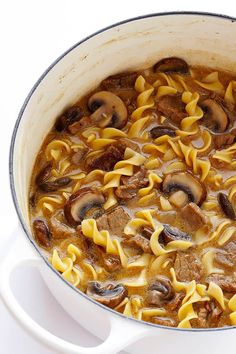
(180, 203, 209, 231)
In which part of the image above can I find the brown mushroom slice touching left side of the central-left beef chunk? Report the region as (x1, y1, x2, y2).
(64, 187, 105, 225)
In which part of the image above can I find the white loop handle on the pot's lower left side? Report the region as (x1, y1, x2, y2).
(0, 230, 150, 354)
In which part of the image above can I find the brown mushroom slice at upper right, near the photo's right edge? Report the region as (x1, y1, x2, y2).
(201, 98, 229, 133)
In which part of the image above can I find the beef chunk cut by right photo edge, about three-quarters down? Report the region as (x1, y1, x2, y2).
(215, 241, 236, 269)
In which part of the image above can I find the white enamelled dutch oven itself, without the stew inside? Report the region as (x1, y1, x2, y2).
(0, 13, 236, 354)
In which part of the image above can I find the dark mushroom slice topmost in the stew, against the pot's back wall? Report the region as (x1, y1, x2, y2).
(153, 57, 188, 74)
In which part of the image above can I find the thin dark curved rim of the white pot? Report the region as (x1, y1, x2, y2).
(9, 11, 236, 332)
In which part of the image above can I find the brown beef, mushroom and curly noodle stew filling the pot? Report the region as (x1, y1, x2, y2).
(30, 58, 236, 328)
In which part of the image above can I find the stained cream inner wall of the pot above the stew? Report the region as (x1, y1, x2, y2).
(12, 13, 236, 229)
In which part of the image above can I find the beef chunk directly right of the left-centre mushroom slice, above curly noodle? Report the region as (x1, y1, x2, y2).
(96, 206, 130, 236)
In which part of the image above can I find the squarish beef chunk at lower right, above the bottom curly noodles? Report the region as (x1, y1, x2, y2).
(174, 251, 202, 282)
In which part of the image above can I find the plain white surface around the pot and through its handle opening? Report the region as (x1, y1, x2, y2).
(0, 0, 236, 354)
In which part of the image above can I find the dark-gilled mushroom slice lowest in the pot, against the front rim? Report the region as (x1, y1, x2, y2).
(86, 281, 128, 308)
